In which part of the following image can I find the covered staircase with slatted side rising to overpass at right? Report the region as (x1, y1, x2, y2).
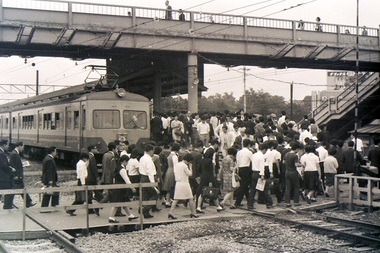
(312, 72, 380, 139)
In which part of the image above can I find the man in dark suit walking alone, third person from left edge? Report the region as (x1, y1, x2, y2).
(41, 146, 59, 207)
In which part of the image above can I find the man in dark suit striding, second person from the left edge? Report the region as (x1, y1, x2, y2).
(9, 141, 36, 207)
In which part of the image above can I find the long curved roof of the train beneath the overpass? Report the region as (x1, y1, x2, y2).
(0, 83, 149, 111)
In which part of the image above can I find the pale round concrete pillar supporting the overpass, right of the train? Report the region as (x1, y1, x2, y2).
(187, 53, 199, 113)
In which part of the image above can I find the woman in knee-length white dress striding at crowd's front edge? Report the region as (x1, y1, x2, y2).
(168, 153, 199, 220)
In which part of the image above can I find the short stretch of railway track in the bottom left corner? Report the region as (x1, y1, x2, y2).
(0, 206, 84, 253)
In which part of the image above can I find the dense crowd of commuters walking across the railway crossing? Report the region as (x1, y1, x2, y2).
(0, 111, 380, 223)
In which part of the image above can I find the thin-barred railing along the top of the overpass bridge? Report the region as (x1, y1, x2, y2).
(0, 0, 380, 37)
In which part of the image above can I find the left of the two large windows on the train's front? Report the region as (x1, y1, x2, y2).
(93, 110, 120, 129)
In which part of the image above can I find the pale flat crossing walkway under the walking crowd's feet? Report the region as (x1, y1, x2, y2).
(0, 196, 336, 240)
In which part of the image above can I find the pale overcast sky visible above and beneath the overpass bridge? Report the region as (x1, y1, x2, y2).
(0, 0, 380, 104)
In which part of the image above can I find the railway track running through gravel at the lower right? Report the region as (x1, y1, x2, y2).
(242, 209, 380, 252)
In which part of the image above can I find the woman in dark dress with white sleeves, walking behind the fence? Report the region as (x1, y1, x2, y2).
(108, 155, 138, 223)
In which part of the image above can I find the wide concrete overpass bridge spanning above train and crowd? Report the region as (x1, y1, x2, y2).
(0, 0, 380, 112)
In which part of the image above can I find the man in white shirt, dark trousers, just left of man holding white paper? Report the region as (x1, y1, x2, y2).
(235, 139, 252, 207)
